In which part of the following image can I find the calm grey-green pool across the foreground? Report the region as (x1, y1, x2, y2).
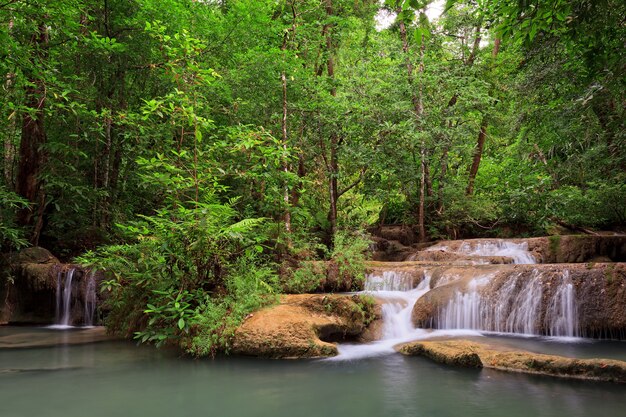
(0, 330, 626, 417)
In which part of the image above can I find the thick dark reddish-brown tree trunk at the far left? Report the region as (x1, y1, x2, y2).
(16, 23, 48, 245)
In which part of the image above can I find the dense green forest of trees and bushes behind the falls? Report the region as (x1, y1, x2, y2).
(0, 0, 626, 354)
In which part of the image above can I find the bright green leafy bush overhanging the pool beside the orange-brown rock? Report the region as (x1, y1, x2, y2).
(78, 203, 275, 354)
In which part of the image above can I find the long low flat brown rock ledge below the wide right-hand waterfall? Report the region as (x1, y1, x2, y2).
(399, 340, 626, 383)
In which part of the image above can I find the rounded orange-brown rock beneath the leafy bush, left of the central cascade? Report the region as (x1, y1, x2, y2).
(232, 294, 380, 358)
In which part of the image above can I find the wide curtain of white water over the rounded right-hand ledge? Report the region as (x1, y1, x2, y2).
(436, 270, 580, 337)
